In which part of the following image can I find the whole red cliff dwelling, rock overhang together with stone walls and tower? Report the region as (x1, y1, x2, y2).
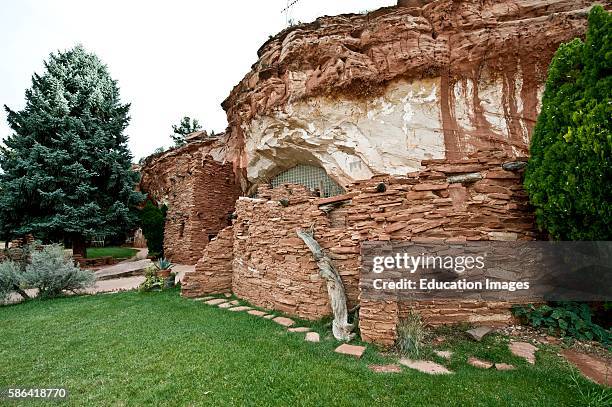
(142, 0, 609, 345)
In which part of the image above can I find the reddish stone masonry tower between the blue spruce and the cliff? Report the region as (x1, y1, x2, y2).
(140, 140, 241, 264)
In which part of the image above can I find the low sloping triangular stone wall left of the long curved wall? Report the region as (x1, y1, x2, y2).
(181, 226, 234, 297)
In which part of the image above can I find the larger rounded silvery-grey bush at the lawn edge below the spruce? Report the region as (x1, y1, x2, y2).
(23, 245, 96, 298)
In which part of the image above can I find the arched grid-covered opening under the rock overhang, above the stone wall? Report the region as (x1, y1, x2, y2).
(272, 164, 344, 198)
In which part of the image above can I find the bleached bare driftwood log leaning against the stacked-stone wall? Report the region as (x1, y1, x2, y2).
(297, 230, 355, 342)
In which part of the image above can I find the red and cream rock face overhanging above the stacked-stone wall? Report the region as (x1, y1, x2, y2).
(223, 0, 608, 184)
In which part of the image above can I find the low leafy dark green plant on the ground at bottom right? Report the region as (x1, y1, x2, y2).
(512, 302, 612, 345)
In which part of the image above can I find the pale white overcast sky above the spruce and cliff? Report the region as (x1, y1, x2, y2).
(0, 0, 396, 161)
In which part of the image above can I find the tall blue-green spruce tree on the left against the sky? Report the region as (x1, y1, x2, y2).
(0, 45, 142, 256)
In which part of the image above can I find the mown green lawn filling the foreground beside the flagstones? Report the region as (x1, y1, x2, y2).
(0, 290, 602, 406)
